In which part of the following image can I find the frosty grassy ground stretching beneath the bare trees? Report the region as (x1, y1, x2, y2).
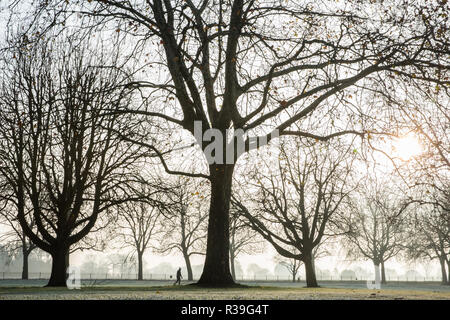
(0, 282, 450, 300)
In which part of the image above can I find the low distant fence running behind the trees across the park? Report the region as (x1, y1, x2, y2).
(0, 271, 441, 282)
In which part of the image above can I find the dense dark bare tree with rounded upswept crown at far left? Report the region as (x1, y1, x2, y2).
(0, 35, 148, 286)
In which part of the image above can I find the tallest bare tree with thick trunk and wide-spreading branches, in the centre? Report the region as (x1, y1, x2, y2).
(16, 0, 449, 285)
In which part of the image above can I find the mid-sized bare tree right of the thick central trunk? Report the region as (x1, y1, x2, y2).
(232, 140, 356, 287)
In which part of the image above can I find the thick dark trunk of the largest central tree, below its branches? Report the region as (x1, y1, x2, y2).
(198, 164, 234, 287)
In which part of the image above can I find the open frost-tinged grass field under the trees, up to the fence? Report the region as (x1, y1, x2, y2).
(0, 280, 450, 300)
